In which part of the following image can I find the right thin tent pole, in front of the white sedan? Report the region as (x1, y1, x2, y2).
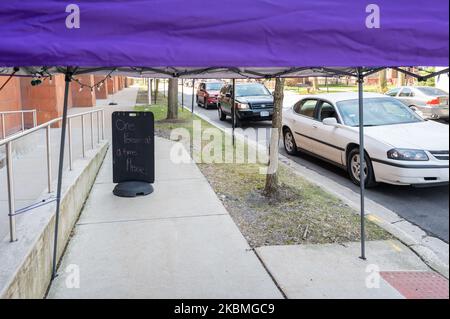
(358, 68, 366, 260)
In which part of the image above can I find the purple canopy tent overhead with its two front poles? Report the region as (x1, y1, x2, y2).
(0, 0, 449, 275)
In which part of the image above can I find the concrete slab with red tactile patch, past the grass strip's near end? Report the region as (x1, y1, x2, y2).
(257, 240, 449, 299)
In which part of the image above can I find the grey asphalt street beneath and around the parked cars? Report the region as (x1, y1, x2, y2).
(179, 86, 449, 243)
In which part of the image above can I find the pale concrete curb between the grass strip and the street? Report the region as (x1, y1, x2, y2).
(183, 106, 449, 279)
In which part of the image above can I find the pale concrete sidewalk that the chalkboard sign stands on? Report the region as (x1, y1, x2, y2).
(48, 138, 282, 299)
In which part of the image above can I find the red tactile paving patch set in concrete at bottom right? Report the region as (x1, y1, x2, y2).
(381, 271, 449, 299)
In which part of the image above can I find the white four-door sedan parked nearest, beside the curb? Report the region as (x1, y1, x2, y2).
(283, 93, 449, 187)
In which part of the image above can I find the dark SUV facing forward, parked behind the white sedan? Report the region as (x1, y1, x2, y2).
(218, 83, 273, 124)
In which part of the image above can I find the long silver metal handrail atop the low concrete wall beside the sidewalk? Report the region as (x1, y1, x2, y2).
(0, 109, 105, 242)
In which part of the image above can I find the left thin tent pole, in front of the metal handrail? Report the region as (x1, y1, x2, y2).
(52, 67, 73, 280)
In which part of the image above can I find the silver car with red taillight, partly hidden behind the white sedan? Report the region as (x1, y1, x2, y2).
(386, 86, 449, 120)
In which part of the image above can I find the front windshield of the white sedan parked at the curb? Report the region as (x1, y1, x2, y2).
(336, 97, 423, 126)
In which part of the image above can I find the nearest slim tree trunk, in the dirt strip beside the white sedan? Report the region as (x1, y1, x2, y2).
(264, 78, 284, 197)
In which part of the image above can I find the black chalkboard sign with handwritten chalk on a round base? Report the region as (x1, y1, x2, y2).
(112, 112, 155, 197)
